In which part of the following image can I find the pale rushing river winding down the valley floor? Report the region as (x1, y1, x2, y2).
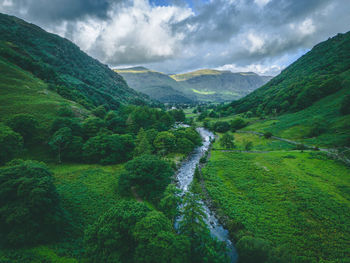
(177, 128, 238, 263)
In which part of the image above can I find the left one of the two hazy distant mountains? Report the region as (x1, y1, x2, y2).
(114, 67, 194, 103)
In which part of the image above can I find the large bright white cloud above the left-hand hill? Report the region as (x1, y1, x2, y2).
(51, 0, 193, 64)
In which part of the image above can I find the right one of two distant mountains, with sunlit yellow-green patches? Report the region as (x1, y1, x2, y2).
(171, 69, 271, 102)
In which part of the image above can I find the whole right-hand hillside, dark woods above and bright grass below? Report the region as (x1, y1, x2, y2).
(230, 32, 350, 147)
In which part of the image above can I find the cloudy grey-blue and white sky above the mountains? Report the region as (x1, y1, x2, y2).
(0, 0, 350, 75)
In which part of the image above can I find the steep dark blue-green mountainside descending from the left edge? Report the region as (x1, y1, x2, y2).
(0, 14, 148, 113)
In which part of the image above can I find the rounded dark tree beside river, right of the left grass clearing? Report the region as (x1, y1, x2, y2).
(119, 155, 173, 201)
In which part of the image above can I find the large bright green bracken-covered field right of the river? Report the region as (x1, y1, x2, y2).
(203, 151, 350, 262)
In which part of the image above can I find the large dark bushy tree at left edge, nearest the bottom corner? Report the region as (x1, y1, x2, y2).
(0, 161, 65, 249)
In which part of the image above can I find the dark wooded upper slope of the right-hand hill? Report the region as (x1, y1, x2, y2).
(232, 32, 350, 114)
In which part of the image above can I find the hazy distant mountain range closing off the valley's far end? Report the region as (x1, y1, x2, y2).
(115, 67, 271, 103)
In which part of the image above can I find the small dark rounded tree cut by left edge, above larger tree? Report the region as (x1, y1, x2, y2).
(0, 123, 23, 164)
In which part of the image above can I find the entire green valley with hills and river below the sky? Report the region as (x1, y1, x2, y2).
(0, 5, 350, 263)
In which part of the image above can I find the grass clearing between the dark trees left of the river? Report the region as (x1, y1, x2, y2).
(0, 164, 124, 263)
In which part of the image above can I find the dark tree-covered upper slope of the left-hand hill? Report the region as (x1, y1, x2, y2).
(0, 13, 145, 106)
